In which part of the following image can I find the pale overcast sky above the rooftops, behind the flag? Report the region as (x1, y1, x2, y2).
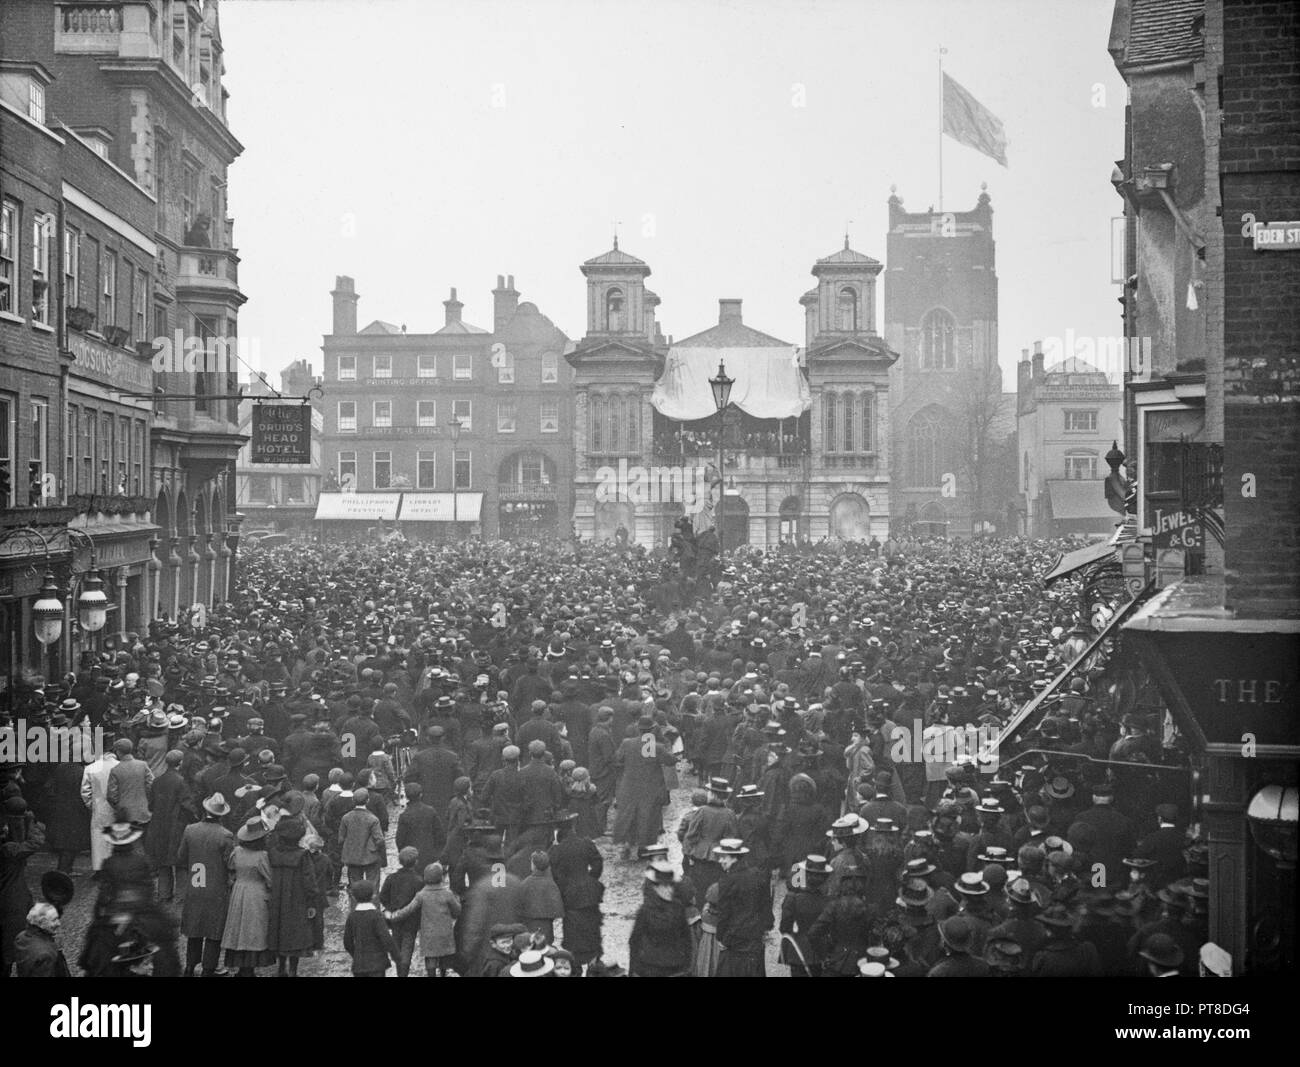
(220, 0, 1123, 389)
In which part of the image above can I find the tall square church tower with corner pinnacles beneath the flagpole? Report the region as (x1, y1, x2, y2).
(884, 190, 1004, 537)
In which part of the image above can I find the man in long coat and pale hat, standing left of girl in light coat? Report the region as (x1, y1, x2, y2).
(176, 793, 235, 977)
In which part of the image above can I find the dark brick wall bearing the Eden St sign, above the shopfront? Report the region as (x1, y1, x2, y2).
(1219, 3, 1300, 617)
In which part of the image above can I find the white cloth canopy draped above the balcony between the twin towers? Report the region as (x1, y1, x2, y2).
(650, 346, 813, 422)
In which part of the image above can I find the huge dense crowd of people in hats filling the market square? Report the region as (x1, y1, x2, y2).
(0, 539, 1222, 977)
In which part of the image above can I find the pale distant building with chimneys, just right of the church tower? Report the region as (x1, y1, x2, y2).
(1015, 342, 1123, 537)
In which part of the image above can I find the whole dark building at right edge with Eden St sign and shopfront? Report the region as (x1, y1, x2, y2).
(1110, 0, 1300, 973)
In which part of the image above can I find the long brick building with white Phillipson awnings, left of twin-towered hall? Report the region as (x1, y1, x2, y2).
(316, 276, 573, 539)
